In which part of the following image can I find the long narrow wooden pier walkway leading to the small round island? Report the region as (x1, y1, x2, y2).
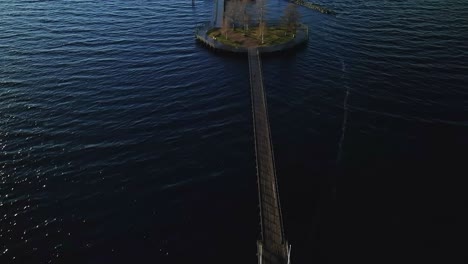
(248, 48, 289, 264)
